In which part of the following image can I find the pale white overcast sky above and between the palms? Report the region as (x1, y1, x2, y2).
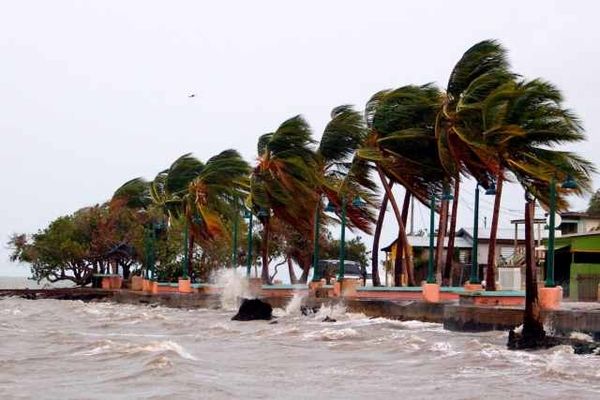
(0, 0, 600, 275)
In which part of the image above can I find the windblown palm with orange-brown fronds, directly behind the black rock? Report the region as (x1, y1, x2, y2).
(248, 116, 317, 283)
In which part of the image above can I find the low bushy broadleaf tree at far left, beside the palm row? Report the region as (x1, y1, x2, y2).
(9, 202, 143, 286)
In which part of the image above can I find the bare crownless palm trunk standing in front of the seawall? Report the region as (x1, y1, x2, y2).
(522, 195, 546, 344)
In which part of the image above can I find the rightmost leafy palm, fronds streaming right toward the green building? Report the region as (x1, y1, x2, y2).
(481, 79, 593, 290)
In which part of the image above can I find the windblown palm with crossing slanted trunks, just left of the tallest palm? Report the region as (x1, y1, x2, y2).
(358, 84, 447, 285)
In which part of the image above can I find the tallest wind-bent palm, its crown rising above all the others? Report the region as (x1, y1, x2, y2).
(436, 40, 514, 285)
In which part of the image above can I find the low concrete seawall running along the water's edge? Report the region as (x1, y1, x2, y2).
(0, 288, 600, 342)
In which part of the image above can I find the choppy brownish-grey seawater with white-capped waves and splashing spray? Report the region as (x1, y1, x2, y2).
(0, 278, 600, 399)
